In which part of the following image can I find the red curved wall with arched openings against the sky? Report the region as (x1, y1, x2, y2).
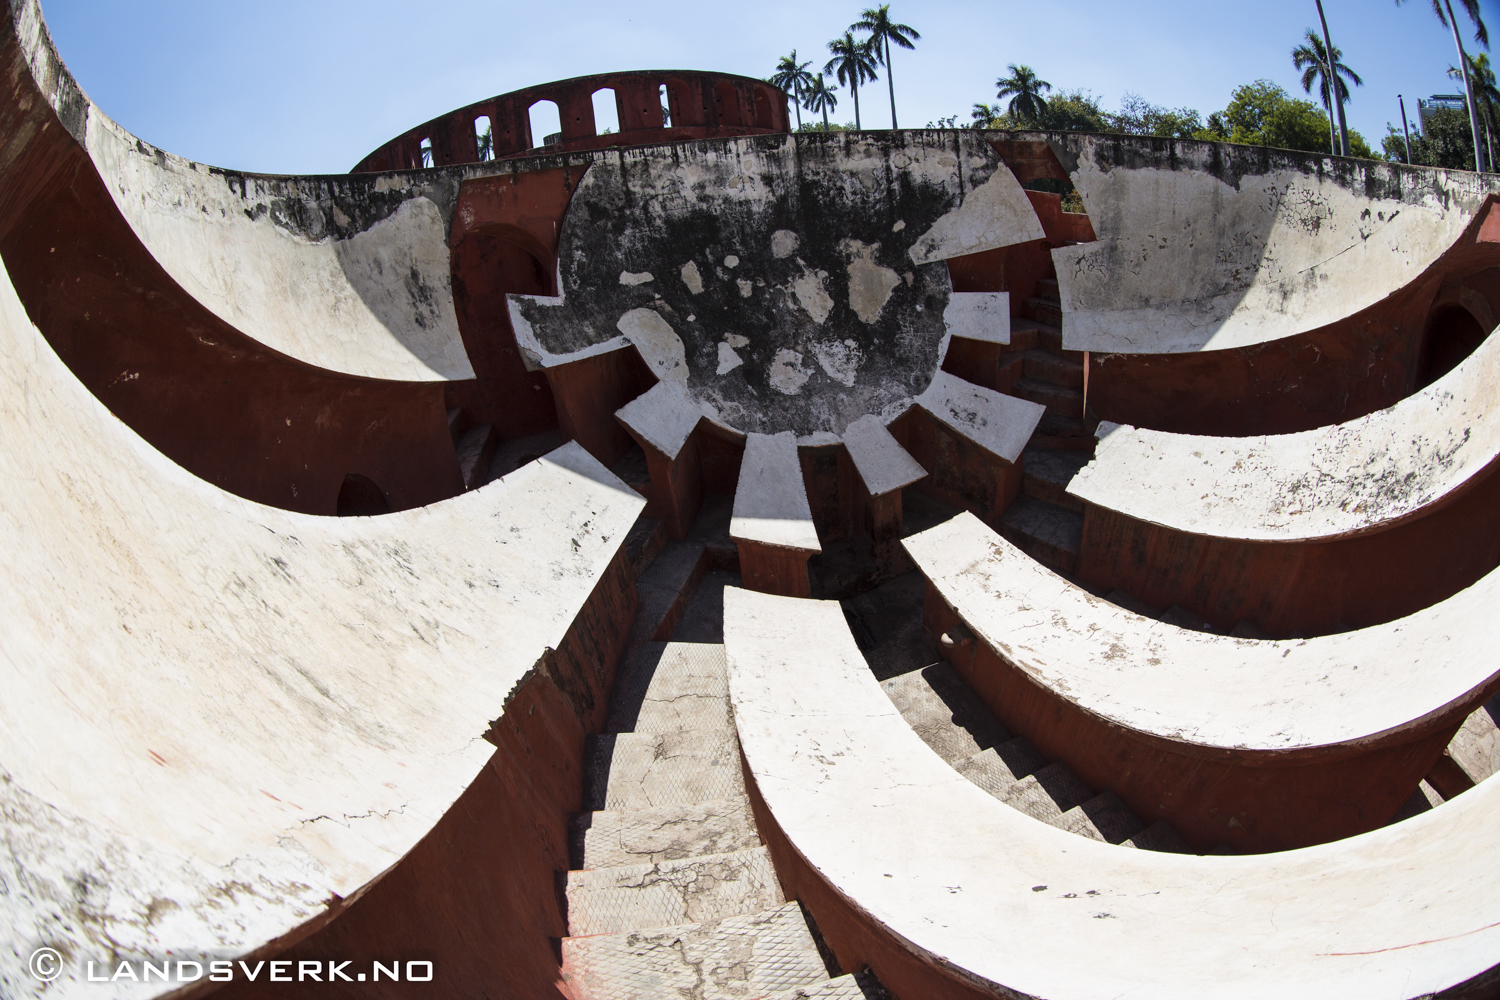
(350, 69, 792, 174)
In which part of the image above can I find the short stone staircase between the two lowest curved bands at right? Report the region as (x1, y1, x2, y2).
(881, 663, 1191, 853)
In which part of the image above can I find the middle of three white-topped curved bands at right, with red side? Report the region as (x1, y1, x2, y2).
(903, 514, 1500, 850)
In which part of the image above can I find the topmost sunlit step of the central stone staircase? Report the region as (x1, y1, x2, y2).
(605, 642, 734, 733)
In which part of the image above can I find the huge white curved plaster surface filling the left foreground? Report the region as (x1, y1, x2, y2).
(0, 256, 645, 997)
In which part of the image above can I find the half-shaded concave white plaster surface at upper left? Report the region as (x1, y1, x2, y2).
(86, 105, 474, 382)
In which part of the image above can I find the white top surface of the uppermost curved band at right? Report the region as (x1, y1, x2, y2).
(1068, 329, 1500, 541)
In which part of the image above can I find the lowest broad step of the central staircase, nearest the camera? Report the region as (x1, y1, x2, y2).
(563, 903, 828, 1000)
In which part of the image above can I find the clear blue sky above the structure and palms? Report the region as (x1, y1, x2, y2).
(42, 0, 1500, 174)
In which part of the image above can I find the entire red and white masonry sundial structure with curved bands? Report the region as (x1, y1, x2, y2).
(0, 0, 1500, 1000)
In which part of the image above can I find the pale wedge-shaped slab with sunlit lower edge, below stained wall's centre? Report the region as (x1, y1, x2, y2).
(729, 430, 822, 552)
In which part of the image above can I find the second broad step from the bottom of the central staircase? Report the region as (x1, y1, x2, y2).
(567, 847, 786, 937)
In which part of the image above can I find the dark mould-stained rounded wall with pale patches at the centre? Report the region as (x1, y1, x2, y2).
(510, 132, 1041, 436)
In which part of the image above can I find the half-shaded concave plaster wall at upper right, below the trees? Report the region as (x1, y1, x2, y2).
(1046, 135, 1500, 354)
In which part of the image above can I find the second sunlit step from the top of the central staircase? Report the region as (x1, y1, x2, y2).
(584, 730, 746, 811)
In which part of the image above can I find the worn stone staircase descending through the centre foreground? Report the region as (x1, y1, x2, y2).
(563, 527, 890, 1000)
